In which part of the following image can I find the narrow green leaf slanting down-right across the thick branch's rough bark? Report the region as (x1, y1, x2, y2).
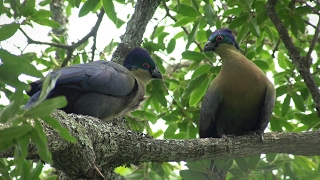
(41, 116, 77, 143)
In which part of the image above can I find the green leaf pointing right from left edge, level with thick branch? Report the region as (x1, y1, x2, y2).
(0, 124, 32, 141)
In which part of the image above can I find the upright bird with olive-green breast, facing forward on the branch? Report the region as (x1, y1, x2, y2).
(199, 29, 276, 179)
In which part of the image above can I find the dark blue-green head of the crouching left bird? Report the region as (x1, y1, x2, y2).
(123, 47, 162, 82)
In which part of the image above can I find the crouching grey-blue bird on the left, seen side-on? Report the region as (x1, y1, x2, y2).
(24, 48, 162, 120)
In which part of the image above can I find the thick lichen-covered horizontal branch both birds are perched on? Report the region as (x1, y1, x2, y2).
(0, 110, 320, 178)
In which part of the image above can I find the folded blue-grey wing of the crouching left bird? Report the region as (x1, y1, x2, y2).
(29, 60, 135, 96)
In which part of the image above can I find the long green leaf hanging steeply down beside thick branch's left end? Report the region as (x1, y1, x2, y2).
(30, 120, 53, 164)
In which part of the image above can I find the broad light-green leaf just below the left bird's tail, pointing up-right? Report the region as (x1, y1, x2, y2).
(24, 96, 67, 118)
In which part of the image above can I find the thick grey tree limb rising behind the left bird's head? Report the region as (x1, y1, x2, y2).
(112, 0, 161, 64)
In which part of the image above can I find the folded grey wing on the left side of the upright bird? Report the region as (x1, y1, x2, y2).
(199, 81, 223, 138)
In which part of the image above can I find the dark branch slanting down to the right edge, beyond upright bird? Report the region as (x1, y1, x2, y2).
(266, 0, 320, 117)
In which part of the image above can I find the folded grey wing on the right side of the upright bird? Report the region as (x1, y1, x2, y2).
(255, 84, 276, 132)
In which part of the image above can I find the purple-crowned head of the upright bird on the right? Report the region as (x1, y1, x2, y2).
(204, 28, 239, 52)
